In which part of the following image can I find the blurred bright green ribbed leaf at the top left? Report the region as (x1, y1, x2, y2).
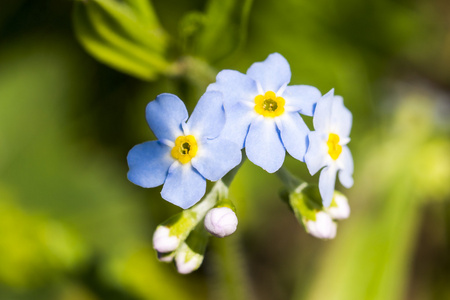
(73, 0, 170, 80)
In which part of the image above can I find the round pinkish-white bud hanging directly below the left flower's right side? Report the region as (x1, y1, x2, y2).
(204, 207, 238, 238)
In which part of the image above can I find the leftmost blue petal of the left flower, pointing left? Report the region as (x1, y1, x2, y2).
(127, 141, 174, 188)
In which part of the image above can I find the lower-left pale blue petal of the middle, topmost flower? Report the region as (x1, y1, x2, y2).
(220, 103, 256, 149)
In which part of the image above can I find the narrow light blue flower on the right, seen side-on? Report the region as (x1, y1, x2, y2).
(305, 90, 353, 207)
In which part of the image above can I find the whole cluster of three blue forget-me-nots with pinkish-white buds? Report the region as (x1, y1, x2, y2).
(128, 53, 353, 272)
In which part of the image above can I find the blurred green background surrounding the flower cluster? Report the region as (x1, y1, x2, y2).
(0, 0, 450, 300)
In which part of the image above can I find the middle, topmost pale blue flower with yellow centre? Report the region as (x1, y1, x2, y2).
(208, 53, 321, 173)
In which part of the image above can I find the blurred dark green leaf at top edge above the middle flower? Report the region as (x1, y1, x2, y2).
(181, 0, 252, 62)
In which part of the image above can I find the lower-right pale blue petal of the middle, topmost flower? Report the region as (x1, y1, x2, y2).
(277, 112, 309, 162)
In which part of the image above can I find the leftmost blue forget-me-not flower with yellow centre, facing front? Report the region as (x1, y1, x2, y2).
(127, 92, 242, 209)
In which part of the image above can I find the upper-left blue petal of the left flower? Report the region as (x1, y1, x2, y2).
(145, 93, 188, 141)
